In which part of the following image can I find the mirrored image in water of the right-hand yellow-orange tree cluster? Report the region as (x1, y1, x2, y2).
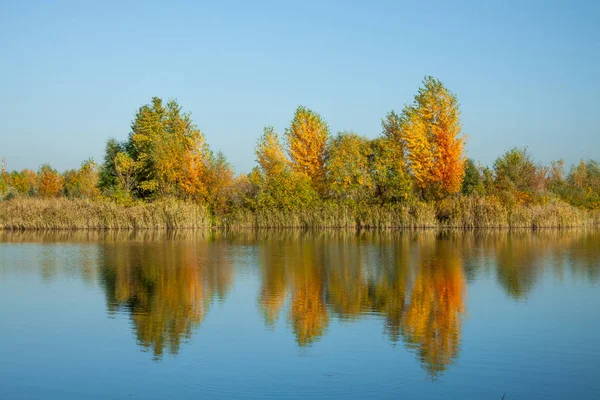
(253, 233, 466, 378)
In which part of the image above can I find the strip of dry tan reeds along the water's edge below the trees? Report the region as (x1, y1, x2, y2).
(0, 196, 600, 230)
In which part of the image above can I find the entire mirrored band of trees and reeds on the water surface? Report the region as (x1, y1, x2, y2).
(0, 230, 600, 378)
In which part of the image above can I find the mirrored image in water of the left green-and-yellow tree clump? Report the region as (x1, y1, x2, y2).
(100, 234, 232, 359)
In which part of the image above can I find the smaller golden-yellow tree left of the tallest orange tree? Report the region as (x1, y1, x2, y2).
(285, 106, 329, 189)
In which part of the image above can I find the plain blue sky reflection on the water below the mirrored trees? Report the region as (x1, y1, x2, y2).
(0, 234, 600, 399)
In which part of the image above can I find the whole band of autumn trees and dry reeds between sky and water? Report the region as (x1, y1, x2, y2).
(0, 77, 600, 228)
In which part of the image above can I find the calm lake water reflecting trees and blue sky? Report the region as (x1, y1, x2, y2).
(0, 230, 600, 400)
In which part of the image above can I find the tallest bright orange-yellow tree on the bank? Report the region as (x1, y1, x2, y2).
(401, 77, 465, 197)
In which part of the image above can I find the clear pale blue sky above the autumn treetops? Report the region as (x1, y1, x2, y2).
(0, 0, 600, 173)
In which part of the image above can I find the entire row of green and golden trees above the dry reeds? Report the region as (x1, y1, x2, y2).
(0, 77, 600, 213)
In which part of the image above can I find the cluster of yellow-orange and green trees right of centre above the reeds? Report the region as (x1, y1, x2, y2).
(250, 77, 465, 209)
